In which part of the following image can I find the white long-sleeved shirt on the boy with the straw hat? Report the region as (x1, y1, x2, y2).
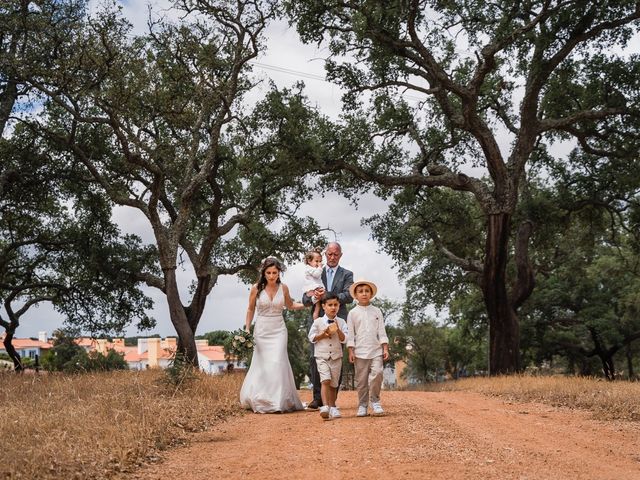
(347, 305, 389, 358)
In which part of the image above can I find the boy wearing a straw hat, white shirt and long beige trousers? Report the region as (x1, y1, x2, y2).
(347, 280, 389, 417)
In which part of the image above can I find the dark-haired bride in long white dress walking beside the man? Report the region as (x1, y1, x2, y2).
(240, 257, 304, 413)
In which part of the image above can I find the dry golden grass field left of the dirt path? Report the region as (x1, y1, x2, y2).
(0, 370, 242, 479)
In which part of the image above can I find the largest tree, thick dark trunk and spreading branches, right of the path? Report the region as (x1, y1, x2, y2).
(286, 0, 640, 374)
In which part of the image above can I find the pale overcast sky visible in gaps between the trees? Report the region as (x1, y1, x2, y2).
(22, 0, 404, 337)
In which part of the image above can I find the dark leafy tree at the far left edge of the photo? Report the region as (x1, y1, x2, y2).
(0, 0, 153, 370)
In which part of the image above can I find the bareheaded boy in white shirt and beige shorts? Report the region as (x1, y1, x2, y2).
(309, 293, 347, 420)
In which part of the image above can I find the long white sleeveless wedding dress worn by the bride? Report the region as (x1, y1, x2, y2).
(240, 285, 303, 413)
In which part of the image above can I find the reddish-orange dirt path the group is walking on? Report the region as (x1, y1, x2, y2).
(134, 392, 640, 480)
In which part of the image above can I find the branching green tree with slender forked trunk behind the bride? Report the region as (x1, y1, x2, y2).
(9, 0, 328, 365)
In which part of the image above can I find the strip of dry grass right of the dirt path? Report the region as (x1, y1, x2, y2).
(435, 375, 640, 421)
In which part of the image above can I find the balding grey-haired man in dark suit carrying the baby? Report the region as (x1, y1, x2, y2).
(302, 242, 353, 410)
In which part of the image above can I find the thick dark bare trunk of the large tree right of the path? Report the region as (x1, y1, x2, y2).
(482, 213, 520, 375)
